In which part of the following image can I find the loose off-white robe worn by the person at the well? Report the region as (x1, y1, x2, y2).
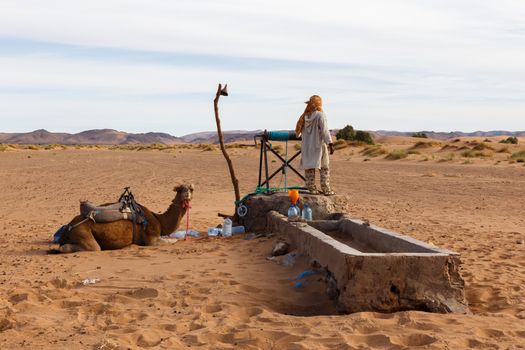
(299, 111, 332, 170)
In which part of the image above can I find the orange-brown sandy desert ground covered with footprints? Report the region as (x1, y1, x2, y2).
(0, 138, 525, 349)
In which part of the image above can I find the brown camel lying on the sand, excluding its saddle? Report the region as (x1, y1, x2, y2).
(49, 185, 194, 253)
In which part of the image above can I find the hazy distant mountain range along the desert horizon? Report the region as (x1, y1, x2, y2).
(0, 129, 525, 145)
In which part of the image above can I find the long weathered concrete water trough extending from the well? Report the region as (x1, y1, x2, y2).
(267, 211, 469, 313)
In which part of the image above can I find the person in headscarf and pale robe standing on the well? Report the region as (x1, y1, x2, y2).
(295, 95, 335, 196)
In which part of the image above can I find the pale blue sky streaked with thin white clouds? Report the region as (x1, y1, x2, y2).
(0, 0, 525, 136)
